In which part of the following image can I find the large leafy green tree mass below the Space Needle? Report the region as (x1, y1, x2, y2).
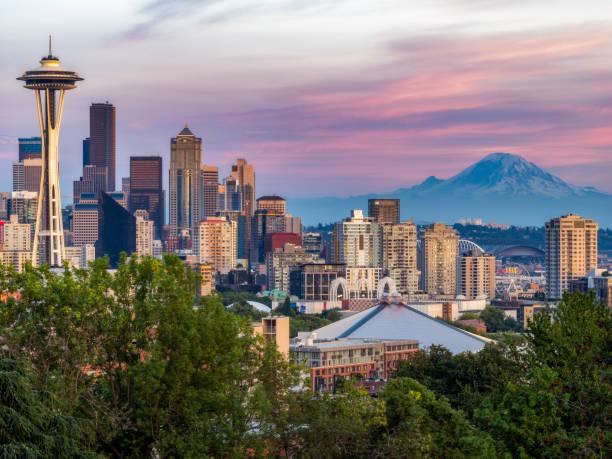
(0, 256, 272, 457)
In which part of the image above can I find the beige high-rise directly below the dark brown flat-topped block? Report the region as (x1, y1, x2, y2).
(381, 221, 421, 293)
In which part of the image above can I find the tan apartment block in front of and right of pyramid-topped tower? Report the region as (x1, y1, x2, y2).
(197, 217, 237, 274)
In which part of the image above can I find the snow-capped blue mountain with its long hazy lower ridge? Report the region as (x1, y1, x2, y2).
(288, 153, 612, 227)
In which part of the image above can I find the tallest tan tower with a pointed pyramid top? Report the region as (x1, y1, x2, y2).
(170, 125, 202, 237)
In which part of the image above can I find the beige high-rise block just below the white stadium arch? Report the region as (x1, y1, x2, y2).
(457, 251, 495, 300)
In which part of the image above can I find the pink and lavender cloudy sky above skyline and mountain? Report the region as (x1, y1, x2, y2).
(0, 0, 612, 197)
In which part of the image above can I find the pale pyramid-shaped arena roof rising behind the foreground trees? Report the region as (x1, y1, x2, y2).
(316, 297, 492, 354)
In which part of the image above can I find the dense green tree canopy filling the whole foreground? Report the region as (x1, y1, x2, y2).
(0, 256, 612, 458)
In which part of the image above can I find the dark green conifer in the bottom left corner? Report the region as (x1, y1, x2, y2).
(0, 359, 95, 458)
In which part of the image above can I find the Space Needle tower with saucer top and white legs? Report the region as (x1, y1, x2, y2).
(17, 35, 83, 267)
